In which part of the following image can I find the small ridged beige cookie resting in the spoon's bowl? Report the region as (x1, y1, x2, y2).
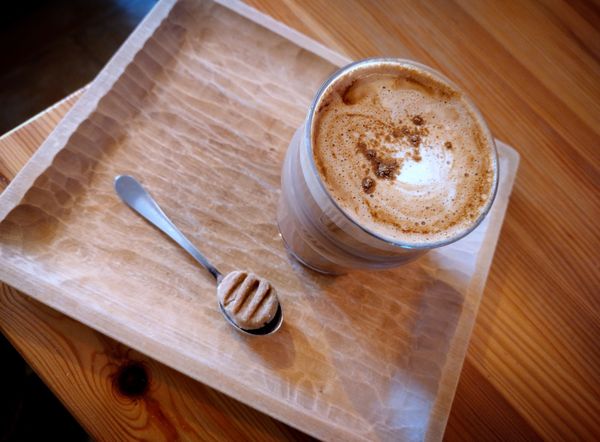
(217, 270, 279, 330)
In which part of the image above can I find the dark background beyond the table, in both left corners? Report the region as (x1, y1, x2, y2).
(0, 0, 156, 441)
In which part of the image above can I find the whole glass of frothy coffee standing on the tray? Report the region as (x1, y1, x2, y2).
(277, 58, 498, 274)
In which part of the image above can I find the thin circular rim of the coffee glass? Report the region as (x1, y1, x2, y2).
(303, 57, 500, 249)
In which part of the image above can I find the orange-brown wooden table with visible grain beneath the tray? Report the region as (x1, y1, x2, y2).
(0, 0, 600, 440)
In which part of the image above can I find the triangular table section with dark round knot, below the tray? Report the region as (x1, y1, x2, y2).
(0, 285, 310, 441)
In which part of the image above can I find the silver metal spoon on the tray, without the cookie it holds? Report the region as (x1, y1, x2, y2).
(115, 175, 283, 336)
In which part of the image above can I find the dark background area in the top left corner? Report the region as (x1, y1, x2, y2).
(0, 0, 156, 135)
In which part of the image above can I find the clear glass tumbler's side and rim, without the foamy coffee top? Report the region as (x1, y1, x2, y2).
(277, 58, 498, 274)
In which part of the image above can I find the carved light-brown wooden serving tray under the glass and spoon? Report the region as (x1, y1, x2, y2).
(0, 0, 518, 440)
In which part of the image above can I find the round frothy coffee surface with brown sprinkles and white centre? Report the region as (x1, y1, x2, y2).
(312, 61, 494, 244)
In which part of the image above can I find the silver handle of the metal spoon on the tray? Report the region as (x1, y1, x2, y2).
(115, 175, 222, 283)
